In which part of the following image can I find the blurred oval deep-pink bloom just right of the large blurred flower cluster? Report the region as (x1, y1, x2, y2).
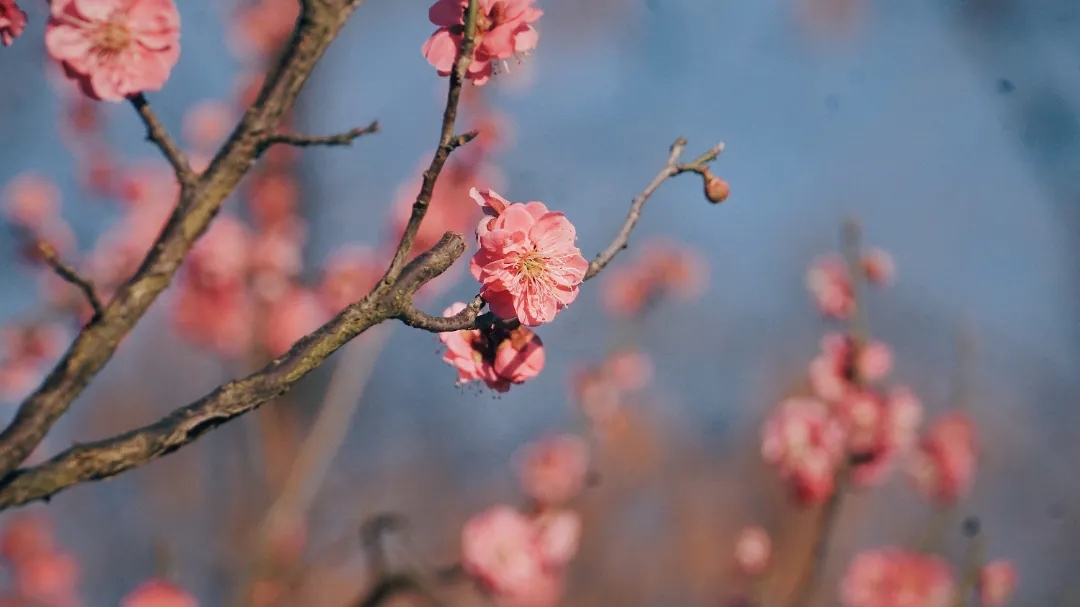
(908, 410, 978, 504)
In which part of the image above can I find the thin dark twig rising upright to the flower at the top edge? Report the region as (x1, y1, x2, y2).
(380, 0, 480, 285)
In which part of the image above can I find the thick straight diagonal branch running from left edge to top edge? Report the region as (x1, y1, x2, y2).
(0, 1, 357, 476)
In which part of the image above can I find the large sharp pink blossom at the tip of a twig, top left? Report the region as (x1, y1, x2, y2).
(45, 0, 180, 102)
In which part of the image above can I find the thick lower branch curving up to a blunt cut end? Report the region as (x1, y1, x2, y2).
(0, 233, 465, 510)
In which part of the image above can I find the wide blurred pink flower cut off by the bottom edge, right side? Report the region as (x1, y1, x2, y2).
(840, 548, 956, 607)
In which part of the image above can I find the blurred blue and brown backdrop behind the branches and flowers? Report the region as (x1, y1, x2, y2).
(0, 0, 1080, 606)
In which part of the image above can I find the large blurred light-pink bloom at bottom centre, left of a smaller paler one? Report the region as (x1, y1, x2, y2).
(461, 505, 563, 607)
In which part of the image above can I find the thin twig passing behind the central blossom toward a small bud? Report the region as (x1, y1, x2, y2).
(397, 137, 724, 333)
